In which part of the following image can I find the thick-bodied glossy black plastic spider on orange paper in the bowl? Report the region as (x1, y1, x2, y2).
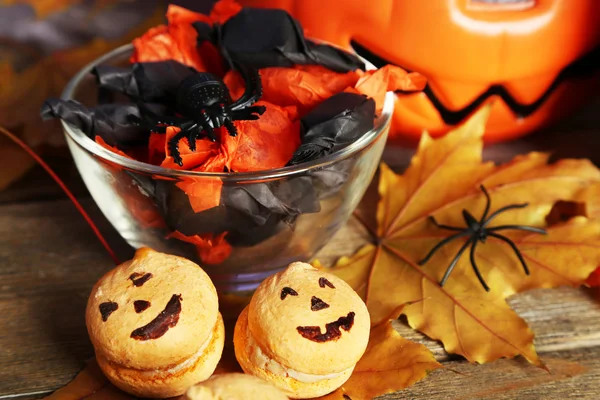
(129, 66, 266, 166)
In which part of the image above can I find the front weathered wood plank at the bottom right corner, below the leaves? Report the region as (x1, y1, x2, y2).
(378, 347, 600, 400)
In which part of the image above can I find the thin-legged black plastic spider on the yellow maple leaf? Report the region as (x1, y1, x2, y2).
(418, 185, 546, 292)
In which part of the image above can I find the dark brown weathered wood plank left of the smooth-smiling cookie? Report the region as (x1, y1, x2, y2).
(0, 200, 131, 397)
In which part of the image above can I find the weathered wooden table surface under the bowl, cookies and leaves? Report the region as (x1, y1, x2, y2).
(0, 101, 600, 400)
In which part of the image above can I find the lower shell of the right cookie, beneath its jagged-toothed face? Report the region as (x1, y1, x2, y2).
(233, 308, 352, 399)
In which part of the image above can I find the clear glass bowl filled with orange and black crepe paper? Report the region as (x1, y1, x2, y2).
(62, 45, 394, 293)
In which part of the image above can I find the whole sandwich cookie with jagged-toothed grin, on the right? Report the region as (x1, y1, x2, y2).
(234, 263, 371, 398)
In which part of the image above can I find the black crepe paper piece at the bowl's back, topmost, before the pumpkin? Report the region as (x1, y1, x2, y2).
(193, 7, 365, 72)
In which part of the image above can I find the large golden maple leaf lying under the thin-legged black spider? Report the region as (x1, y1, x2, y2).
(332, 108, 600, 366)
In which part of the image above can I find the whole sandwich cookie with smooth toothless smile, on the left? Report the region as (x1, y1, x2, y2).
(86, 248, 225, 398)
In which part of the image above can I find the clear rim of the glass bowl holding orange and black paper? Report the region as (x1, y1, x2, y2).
(61, 44, 394, 181)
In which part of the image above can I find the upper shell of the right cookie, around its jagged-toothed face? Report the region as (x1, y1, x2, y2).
(248, 263, 371, 375)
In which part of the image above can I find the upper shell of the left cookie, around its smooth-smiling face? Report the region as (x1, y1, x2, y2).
(86, 248, 218, 370)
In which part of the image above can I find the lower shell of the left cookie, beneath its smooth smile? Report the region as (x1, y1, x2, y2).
(96, 314, 225, 399)
